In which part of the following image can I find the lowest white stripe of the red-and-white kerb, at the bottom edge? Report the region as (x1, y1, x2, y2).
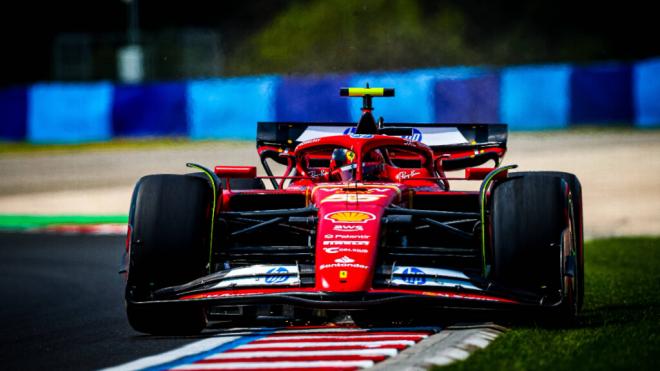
(172, 361, 374, 371)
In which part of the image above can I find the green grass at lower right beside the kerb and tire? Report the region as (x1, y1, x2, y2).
(437, 237, 660, 371)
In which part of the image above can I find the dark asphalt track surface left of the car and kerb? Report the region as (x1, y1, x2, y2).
(0, 233, 198, 370)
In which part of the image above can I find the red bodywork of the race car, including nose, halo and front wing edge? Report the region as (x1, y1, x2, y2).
(166, 135, 515, 303)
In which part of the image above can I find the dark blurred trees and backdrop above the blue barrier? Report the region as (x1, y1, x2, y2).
(0, 0, 660, 85)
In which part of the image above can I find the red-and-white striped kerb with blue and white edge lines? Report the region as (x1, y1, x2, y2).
(100, 327, 435, 371)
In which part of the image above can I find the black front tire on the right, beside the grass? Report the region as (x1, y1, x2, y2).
(491, 173, 582, 321)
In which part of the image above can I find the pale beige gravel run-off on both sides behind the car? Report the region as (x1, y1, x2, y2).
(0, 130, 660, 238)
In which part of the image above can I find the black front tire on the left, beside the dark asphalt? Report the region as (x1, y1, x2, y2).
(126, 175, 213, 334)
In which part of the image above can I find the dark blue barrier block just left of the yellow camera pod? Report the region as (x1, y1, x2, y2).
(275, 75, 351, 122)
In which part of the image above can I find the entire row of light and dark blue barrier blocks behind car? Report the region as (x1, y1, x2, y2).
(0, 59, 660, 143)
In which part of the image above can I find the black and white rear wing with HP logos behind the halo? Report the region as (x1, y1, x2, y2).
(257, 122, 507, 170)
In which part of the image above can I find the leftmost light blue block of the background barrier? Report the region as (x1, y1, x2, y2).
(27, 82, 113, 143)
